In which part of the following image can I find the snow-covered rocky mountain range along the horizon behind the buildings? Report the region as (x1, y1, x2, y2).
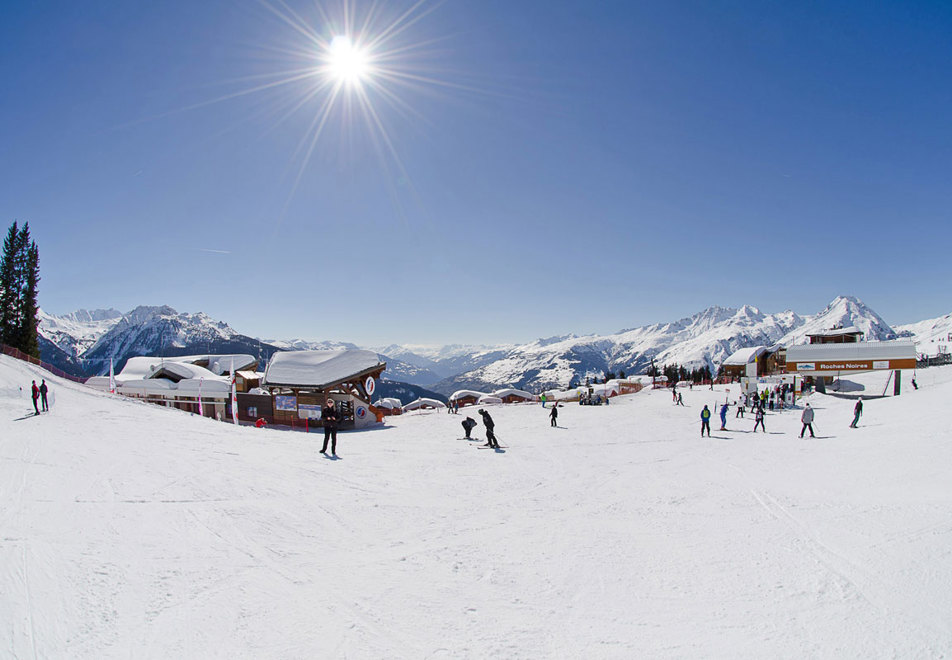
(40, 296, 952, 394)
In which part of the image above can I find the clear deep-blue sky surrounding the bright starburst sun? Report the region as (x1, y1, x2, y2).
(0, 0, 952, 343)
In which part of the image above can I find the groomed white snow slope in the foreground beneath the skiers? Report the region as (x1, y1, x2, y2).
(0, 356, 952, 658)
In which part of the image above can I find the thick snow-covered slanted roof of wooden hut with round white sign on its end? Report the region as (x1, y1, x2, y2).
(262, 350, 386, 387)
